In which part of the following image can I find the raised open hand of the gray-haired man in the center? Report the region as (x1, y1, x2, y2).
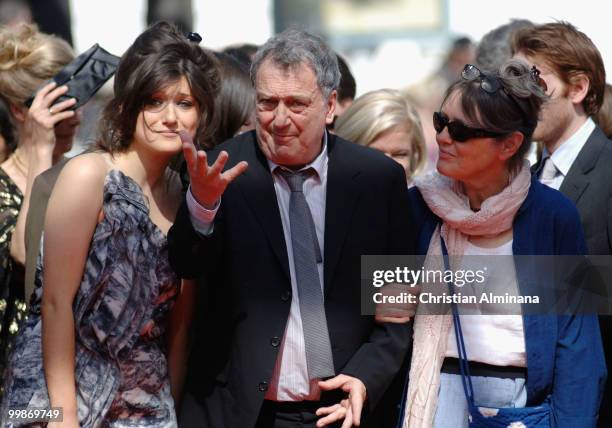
(179, 131, 249, 208)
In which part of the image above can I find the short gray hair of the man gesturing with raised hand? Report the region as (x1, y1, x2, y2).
(251, 28, 340, 98)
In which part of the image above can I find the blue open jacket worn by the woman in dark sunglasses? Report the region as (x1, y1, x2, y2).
(409, 178, 606, 428)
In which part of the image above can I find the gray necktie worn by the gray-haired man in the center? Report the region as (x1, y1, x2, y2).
(278, 169, 335, 379)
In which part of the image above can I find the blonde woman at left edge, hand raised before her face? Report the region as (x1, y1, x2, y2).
(0, 24, 80, 395)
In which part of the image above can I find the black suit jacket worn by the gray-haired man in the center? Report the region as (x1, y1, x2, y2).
(168, 132, 414, 428)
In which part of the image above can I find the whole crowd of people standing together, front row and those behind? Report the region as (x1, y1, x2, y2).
(0, 11, 612, 428)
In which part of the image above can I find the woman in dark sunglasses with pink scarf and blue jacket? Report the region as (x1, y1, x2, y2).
(388, 61, 606, 428)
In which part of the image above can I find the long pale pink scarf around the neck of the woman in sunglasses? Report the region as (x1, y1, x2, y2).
(403, 162, 531, 428)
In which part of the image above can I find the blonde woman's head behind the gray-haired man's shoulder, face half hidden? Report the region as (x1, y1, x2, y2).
(334, 89, 427, 184)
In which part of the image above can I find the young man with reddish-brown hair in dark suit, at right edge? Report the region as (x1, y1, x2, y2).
(512, 22, 612, 427)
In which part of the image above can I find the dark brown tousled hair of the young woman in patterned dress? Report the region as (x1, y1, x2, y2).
(97, 22, 219, 153)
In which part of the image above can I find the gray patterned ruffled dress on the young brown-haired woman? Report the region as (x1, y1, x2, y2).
(0, 170, 180, 427)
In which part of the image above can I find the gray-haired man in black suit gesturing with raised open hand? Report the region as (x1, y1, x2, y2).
(168, 30, 413, 428)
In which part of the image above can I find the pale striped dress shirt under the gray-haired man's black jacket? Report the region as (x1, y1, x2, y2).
(187, 133, 328, 401)
